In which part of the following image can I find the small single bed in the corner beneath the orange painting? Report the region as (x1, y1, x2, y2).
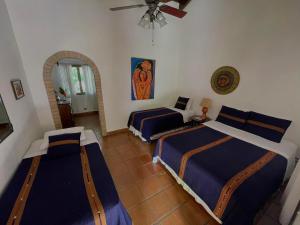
(127, 107, 194, 142)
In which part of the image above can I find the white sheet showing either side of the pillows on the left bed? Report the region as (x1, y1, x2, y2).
(23, 130, 102, 159)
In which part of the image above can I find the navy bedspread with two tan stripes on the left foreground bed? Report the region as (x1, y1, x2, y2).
(0, 143, 131, 225)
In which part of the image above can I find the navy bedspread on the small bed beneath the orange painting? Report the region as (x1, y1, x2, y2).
(128, 108, 184, 141)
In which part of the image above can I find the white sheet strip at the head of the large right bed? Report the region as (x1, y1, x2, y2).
(204, 120, 298, 180)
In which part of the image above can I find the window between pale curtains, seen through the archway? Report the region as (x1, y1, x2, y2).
(71, 65, 86, 95)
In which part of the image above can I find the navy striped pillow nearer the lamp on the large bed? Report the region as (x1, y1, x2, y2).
(216, 106, 249, 129)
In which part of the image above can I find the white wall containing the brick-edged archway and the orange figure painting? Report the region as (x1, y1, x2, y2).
(6, 0, 178, 131)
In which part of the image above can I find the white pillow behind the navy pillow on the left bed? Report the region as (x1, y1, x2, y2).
(40, 127, 86, 150)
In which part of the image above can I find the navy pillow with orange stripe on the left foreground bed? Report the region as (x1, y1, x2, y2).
(47, 133, 81, 158)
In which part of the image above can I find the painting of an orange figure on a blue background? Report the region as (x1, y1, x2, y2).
(131, 58, 155, 100)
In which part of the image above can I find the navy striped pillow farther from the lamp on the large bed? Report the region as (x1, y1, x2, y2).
(244, 112, 292, 143)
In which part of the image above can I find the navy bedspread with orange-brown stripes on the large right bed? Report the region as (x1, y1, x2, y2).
(154, 125, 287, 225)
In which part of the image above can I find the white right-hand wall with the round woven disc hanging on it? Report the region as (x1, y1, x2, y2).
(179, 0, 300, 149)
